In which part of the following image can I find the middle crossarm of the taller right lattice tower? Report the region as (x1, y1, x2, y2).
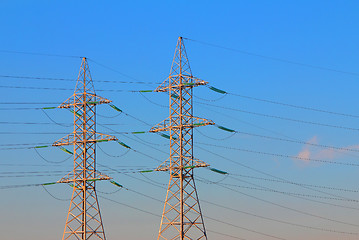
(150, 116, 215, 132)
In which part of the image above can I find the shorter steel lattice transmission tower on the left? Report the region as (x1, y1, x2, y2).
(53, 58, 117, 240)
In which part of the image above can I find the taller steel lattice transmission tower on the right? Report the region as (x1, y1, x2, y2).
(150, 37, 214, 240)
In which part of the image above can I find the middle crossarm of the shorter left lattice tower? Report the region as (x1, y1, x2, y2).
(52, 133, 118, 147)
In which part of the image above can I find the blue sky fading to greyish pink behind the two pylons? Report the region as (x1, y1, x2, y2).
(0, 0, 359, 240)
